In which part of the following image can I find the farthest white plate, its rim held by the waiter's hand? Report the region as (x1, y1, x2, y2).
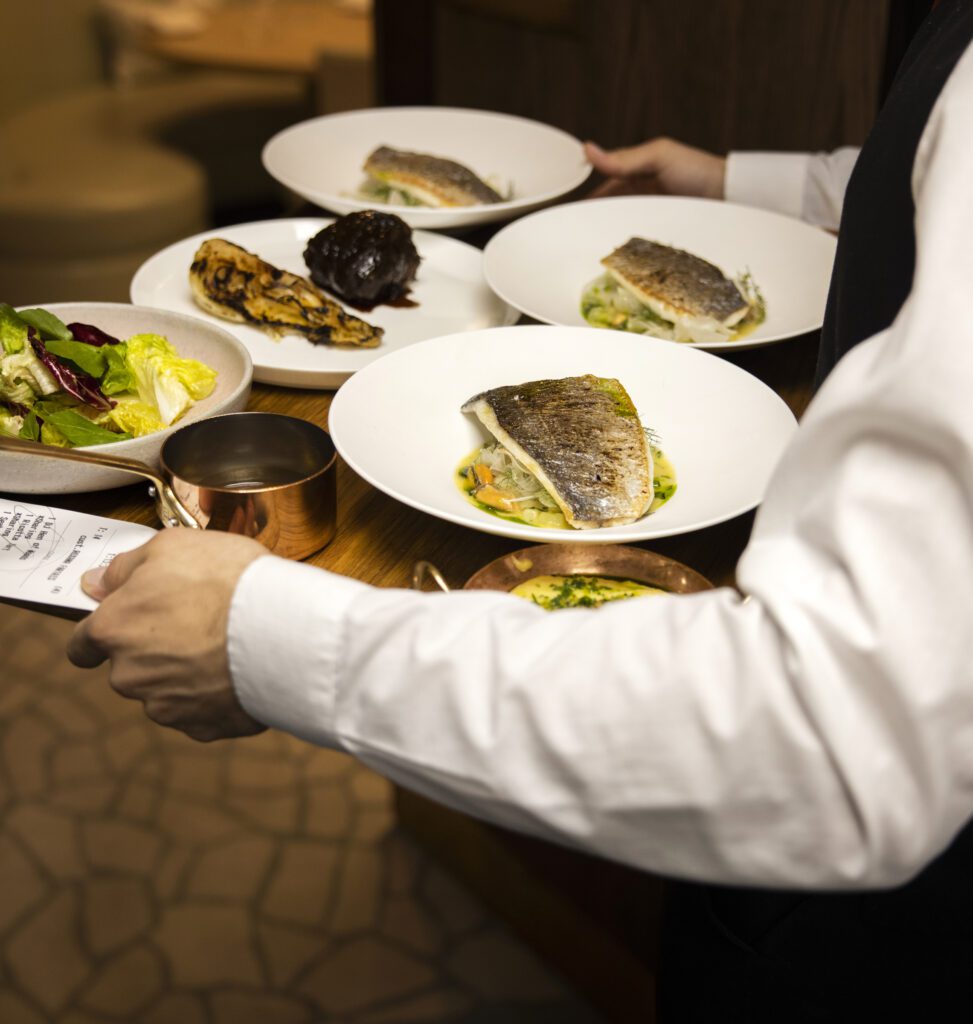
(263, 106, 591, 228)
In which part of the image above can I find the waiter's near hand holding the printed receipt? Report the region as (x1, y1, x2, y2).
(68, 529, 267, 740)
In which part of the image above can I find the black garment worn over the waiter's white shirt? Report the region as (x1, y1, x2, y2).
(660, 0, 973, 1024)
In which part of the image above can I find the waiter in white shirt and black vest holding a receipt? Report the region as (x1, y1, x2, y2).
(70, 0, 973, 1022)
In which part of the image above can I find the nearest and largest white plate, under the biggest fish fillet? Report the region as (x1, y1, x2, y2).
(329, 327, 797, 544)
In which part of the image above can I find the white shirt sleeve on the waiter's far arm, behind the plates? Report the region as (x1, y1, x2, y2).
(724, 146, 859, 230)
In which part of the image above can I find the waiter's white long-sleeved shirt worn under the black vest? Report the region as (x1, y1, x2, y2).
(229, 49, 973, 888)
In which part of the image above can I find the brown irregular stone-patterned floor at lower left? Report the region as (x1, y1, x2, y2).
(0, 607, 598, 1024)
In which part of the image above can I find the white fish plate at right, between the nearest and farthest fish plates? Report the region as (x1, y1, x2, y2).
(483, 196, 835, 349)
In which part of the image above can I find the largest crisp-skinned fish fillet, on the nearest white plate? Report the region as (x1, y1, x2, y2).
(462, 374, 653, 529)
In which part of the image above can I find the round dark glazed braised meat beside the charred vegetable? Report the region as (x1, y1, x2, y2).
(304, 210, 419, 308)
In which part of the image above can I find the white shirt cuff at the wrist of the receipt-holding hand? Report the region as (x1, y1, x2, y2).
(226, 556, 370, 748)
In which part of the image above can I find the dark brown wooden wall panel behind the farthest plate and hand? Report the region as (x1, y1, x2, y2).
(376, 0, 894, 151)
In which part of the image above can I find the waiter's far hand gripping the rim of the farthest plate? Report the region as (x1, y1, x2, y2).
(585, 138, 726, 199)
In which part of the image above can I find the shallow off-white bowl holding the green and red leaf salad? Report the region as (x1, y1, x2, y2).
(0, 302, 253, 495)
